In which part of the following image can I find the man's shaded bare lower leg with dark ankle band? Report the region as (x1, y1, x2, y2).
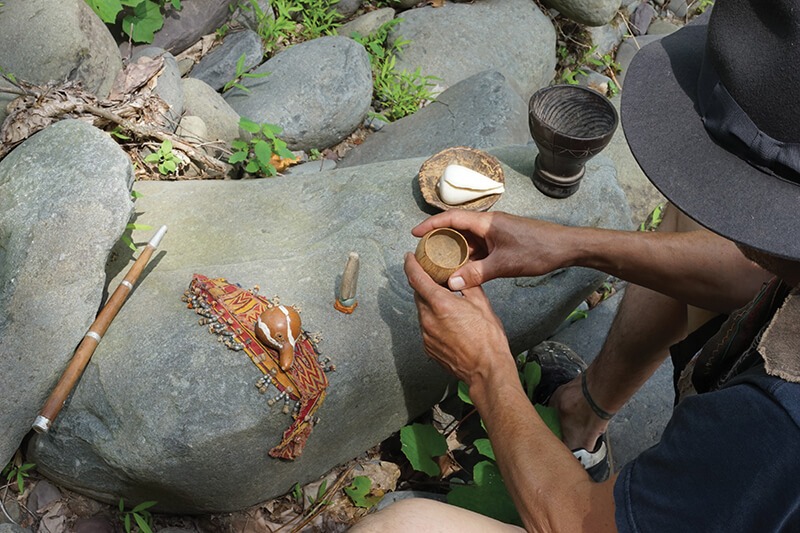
(550, 208, 767, 450)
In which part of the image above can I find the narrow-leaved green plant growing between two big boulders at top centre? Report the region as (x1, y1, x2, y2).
(352, 18, 439, 122)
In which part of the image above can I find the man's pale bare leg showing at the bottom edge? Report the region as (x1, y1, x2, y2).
(349, 498, 525, 533)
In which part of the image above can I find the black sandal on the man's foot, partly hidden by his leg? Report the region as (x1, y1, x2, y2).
(527, 341, 613, 482)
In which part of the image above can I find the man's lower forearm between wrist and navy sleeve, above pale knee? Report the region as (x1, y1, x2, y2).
(470, 360, 616, 531)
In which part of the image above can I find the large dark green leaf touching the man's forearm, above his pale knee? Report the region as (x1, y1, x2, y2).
(447, 461, 522, 526)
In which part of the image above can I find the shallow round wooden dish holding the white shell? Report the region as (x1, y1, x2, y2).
(419, 146, 505, 211)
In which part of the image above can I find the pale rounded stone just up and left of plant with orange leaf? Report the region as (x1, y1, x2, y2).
(183, 78, 240, 143)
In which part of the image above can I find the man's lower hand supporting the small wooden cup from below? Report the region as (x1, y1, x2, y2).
(405, 253, 516, 385)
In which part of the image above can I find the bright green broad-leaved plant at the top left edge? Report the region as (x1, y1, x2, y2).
(86, 0, 181, 43)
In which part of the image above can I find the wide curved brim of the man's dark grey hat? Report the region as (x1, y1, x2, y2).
(621, 24, 800, 259)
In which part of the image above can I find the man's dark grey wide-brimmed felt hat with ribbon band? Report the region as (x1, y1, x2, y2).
(621, 0, 800, 260)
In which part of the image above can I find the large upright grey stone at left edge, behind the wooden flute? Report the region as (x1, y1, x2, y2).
(0, 120, 133, 470)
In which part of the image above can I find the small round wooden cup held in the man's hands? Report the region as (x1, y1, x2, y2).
(414, 228, 469, 285)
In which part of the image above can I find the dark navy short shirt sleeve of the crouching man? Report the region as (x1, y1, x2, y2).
(614, 379, 800, 532)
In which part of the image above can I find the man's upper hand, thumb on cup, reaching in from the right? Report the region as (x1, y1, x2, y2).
(411, 209, 575, 290)
